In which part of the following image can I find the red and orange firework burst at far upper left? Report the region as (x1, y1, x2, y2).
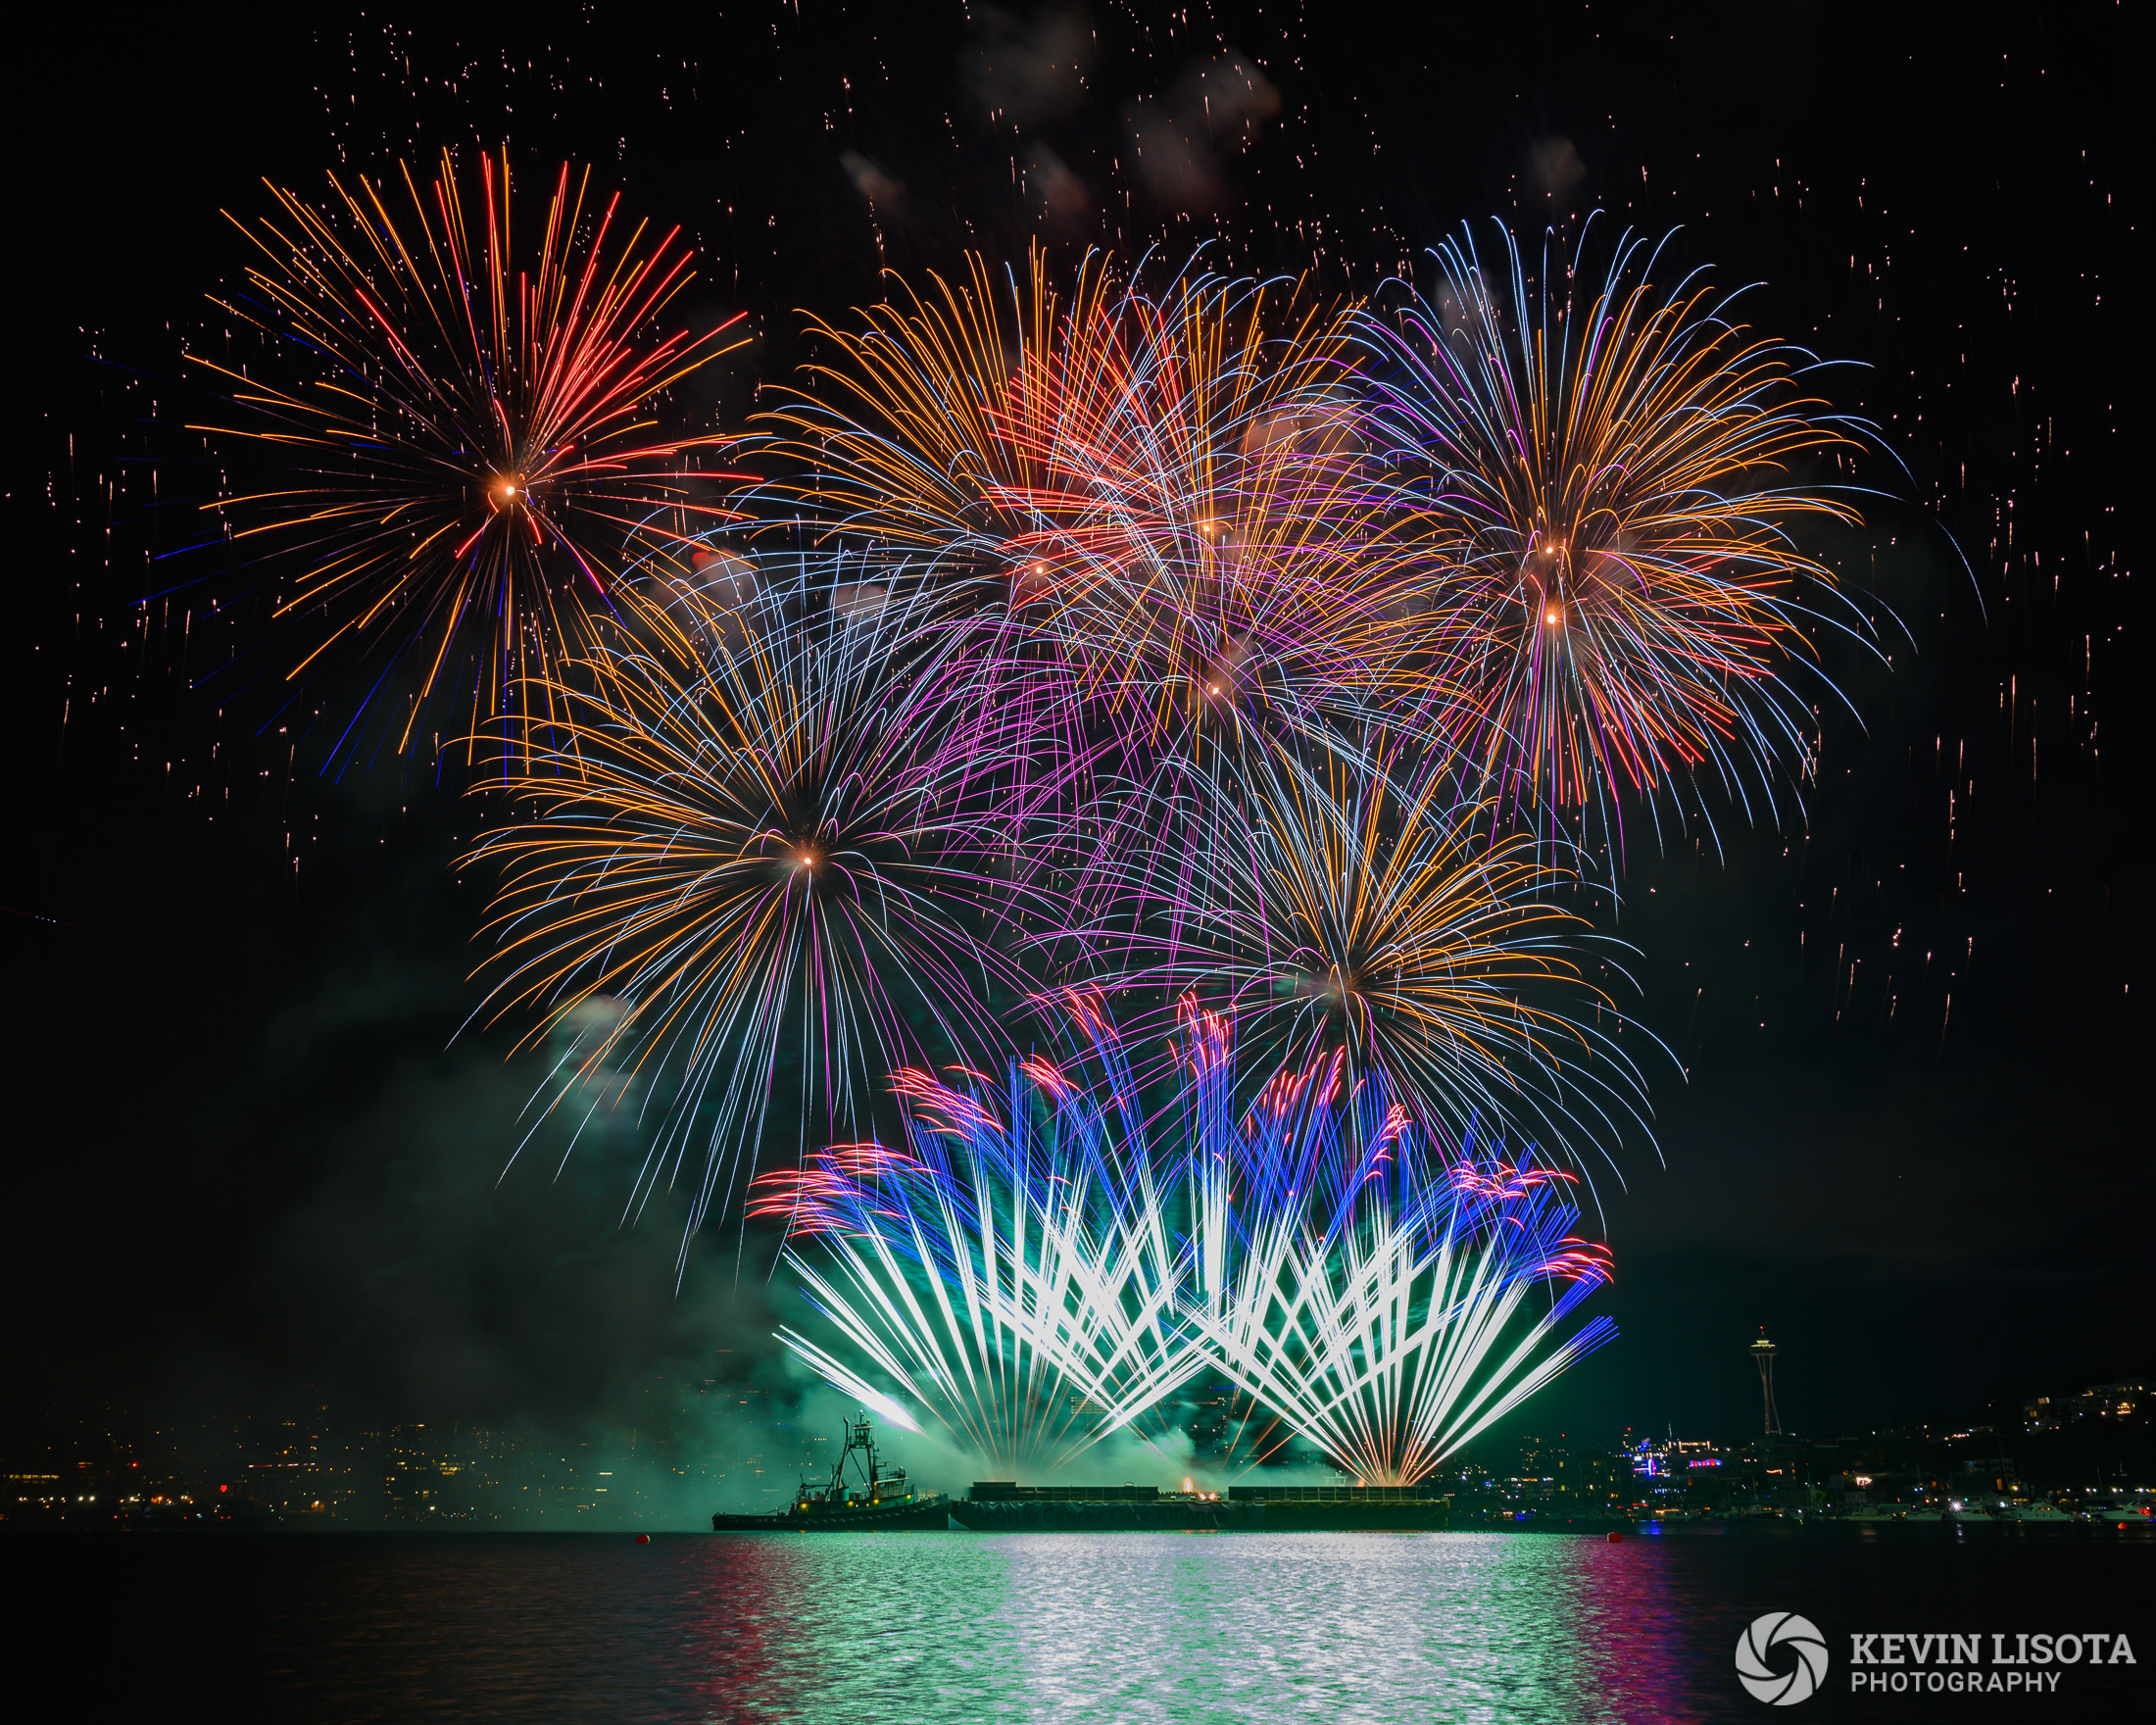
(190, 153, 746, 753)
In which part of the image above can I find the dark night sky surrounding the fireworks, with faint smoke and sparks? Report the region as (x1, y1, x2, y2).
(0, 0, 2156, 1436)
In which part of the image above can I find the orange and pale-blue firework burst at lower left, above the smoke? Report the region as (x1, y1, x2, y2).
(470, 559, 1046, 1276)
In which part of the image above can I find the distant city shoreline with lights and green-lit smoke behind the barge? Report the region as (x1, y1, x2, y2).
(0, 1354, 2156, 1531)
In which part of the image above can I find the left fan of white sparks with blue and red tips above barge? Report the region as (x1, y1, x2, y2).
(753, 1005, 1200, 1477)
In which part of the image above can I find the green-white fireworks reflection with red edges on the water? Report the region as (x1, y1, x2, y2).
(705, 1533, 1690, 1723)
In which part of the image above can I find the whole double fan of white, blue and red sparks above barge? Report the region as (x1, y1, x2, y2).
(759, 994, 1615, 1484)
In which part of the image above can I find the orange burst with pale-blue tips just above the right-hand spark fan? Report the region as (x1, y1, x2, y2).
(1102, 757, 1645, 1166)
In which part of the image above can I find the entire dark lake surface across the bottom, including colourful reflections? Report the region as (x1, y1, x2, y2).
(0, 1527, 2156, 1725)
